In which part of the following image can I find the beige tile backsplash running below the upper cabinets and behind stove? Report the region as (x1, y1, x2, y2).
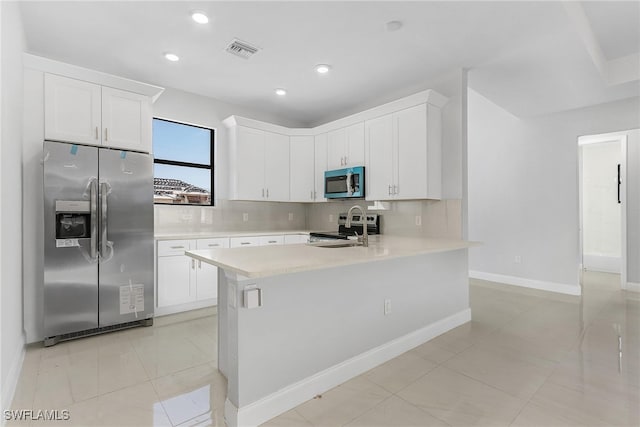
(155, 199, 462, 239)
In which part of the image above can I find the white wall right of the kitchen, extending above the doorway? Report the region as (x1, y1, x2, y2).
(468, 89, 640, 293)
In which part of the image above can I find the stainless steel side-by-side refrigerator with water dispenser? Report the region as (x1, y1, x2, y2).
(43, 141, 154, 346)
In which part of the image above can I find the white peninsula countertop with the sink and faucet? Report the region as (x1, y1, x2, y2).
(185, 235, 479, 278)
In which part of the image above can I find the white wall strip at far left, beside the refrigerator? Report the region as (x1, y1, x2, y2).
(0, 2, 25, 409)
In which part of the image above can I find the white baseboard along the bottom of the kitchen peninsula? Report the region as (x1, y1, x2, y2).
(224, 309, 471, 427)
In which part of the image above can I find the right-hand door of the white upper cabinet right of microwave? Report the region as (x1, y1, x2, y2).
(393, 104, 430, 199)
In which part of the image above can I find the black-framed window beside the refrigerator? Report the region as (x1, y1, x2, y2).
(153, 118, 214, 206)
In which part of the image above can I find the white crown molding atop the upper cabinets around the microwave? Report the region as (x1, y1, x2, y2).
(222, 89, 449, 136)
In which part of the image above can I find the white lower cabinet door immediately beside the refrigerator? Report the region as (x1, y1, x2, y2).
(158, 255, 196, 307)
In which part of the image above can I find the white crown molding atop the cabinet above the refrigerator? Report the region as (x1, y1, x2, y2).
(23, 53, 164, 102)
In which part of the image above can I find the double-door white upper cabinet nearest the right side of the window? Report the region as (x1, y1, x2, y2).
(230, 125, 289, 202)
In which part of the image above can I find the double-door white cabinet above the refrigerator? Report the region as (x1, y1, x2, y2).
(44, 73, 152, 152)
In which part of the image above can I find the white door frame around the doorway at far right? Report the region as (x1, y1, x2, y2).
(578, 131, 627, 289)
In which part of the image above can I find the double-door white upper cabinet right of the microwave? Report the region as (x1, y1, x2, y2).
(365, 104, 441, 200)
